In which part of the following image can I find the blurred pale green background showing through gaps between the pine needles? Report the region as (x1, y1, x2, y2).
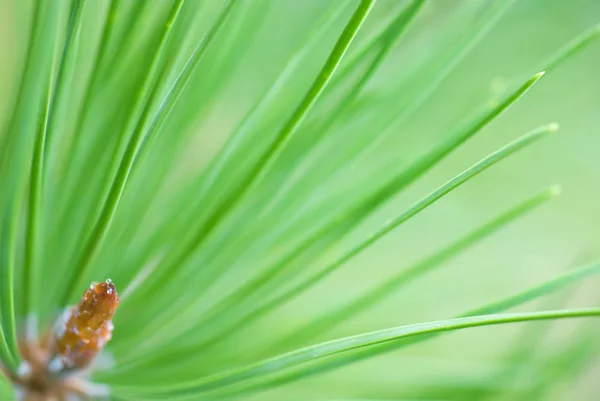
(0, 0, 600, 400)
